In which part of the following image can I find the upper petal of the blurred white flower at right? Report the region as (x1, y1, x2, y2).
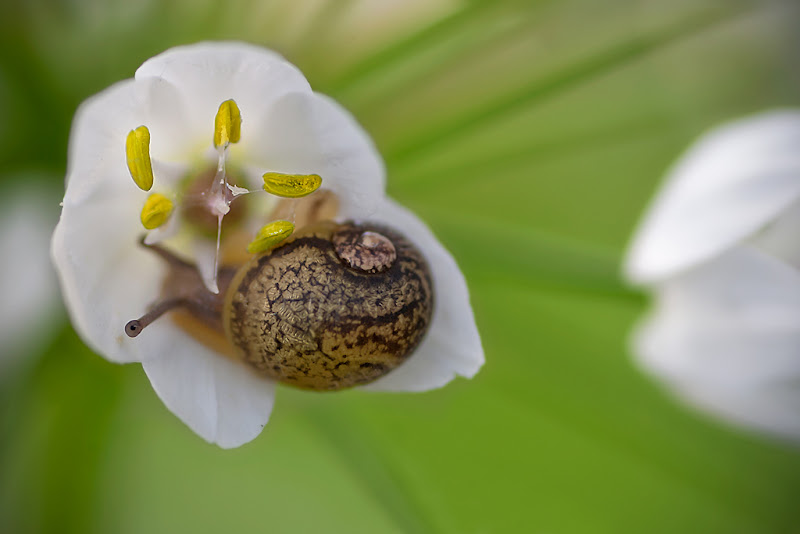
(626, 111, 800, 283)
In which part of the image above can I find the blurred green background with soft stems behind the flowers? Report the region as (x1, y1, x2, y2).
(0, 0, 800, 534)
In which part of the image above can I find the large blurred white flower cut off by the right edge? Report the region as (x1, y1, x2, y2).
(626, 111, 800, 440)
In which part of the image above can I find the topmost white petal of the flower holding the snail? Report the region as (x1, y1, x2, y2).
(136, 42, 311, 151)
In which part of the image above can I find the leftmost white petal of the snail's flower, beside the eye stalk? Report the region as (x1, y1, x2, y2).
(52, 80, 164, 362)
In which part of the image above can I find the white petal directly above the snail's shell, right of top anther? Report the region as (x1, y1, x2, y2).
(250, 93, 386, 220)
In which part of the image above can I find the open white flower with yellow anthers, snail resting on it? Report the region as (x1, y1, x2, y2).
(52, 43, 483, 448)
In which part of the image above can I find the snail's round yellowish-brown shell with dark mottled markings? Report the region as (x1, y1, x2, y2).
(223, 220, 433, 390)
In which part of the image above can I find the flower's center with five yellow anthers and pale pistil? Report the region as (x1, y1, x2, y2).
(125, 99, 322, 293)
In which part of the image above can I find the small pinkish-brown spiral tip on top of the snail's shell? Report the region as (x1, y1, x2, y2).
(331, 227, 397, 273)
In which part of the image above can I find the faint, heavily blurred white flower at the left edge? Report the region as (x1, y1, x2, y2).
(0, 182, 61, 379)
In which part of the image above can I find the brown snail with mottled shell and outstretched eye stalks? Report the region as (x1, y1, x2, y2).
(125, 221, 434, 390)
